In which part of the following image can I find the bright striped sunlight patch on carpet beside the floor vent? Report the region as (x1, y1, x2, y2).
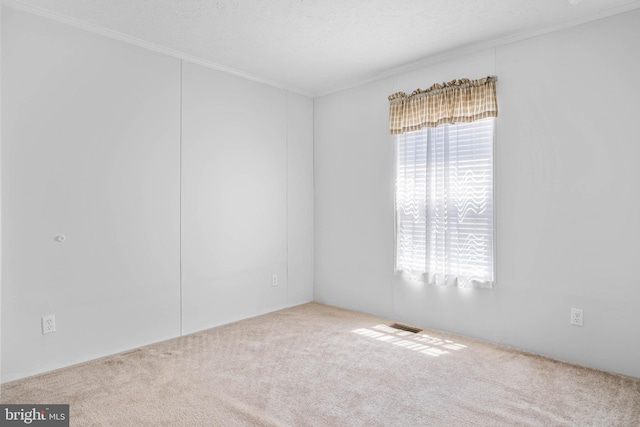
(352, 325, 467, 357)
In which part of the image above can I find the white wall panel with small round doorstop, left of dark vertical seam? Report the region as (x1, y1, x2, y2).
(2, 9, 180, 380)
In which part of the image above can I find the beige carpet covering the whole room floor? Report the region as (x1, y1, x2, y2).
(2, 303, 640, 427)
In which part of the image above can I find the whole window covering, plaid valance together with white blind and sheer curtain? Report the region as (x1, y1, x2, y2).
(389, 76, 498, 288)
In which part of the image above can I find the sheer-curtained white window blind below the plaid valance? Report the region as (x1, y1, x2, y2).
(396, 117, 495, 288)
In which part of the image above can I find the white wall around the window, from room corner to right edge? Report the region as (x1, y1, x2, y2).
(314, 10, 640, 377)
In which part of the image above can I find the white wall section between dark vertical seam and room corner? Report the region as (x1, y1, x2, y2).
(182, 63, 313, 333)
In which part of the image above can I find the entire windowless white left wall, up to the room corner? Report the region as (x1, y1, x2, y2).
(2, 8, 313, 381)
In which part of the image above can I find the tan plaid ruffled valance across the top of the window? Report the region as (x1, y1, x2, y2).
(389, 76, 498, 134)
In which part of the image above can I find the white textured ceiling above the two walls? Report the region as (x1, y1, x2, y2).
(3, 0, 640, 95)
